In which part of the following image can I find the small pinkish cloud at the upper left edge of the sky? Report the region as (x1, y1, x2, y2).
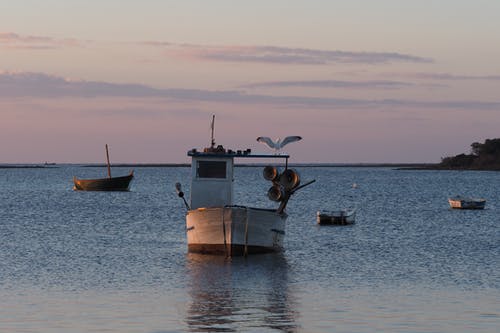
(0, 32, 82, 49)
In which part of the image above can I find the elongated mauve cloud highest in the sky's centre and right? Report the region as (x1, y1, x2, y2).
(142, 41, 433, 65)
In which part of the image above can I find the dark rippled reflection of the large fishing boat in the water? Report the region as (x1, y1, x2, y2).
(186, 253, 298, 332)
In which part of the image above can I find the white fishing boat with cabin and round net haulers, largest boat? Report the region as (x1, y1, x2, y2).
(176, 115, 314, 256)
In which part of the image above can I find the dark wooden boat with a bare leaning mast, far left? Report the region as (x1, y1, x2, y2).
(73, 145, 134, 191)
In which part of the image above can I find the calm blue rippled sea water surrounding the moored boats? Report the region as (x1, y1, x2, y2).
(0, 166, 500, 333)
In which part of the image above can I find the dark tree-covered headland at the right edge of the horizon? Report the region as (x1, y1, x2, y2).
(437, 138, 500, 170)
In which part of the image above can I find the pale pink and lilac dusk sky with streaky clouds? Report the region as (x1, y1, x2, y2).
(0, 0, 500, 163)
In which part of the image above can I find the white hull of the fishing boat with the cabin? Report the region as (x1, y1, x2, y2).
(186, 206, 287, 256)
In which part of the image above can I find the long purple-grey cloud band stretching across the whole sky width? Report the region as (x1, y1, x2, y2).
(0, 72, 500, 112)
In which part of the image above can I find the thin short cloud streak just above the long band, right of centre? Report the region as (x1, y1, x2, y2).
(241, 80, 414, 89)
